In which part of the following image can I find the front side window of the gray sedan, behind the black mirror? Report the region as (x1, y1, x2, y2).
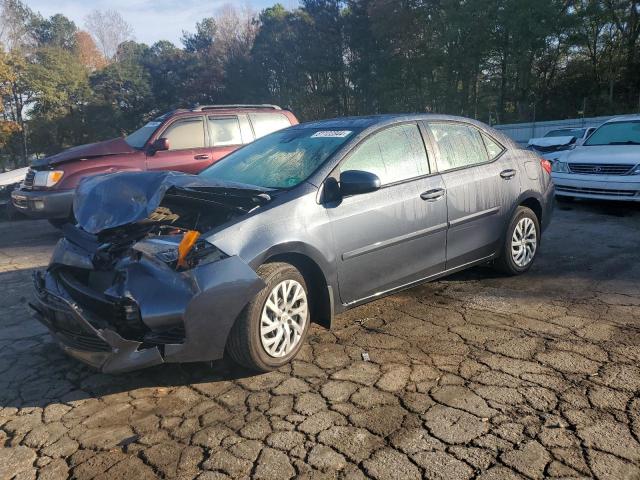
(340, 124, 429, 185)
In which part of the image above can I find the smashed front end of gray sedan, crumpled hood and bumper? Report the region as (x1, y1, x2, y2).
(32, 173, 268, 373)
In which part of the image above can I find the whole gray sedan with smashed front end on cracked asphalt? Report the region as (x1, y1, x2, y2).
(33, 115, 553, 372)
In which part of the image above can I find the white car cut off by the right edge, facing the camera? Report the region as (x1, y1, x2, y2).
(551, 115, 640, 202)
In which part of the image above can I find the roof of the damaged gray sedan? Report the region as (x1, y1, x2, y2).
(292, 113, 486, 129)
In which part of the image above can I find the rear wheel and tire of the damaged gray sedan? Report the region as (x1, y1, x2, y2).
(495, 206, 540, 275)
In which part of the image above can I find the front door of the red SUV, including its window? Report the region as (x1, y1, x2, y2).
(147, 115, 212, 173)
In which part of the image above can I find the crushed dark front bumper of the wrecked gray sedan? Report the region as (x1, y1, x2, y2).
(32, 239, 264, 373)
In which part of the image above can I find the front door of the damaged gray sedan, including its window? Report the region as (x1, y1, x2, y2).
(328, 123, 447, 303)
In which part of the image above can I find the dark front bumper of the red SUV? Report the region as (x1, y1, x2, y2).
(11, 189, 74, 219)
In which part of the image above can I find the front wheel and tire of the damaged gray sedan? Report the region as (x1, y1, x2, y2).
(226, 262, 311, 372)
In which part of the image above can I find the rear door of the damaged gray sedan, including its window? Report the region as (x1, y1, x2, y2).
(427, 122, 520, 269)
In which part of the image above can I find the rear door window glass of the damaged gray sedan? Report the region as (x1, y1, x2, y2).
(428, 123, 489, 172)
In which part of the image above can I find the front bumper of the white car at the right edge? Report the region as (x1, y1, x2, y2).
(552, 172, 640, 202)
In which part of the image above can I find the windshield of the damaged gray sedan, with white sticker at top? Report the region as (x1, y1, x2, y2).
(199, 128, 356, 188)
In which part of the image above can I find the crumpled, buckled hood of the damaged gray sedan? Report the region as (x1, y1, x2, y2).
(73, 171, 270, 234)
